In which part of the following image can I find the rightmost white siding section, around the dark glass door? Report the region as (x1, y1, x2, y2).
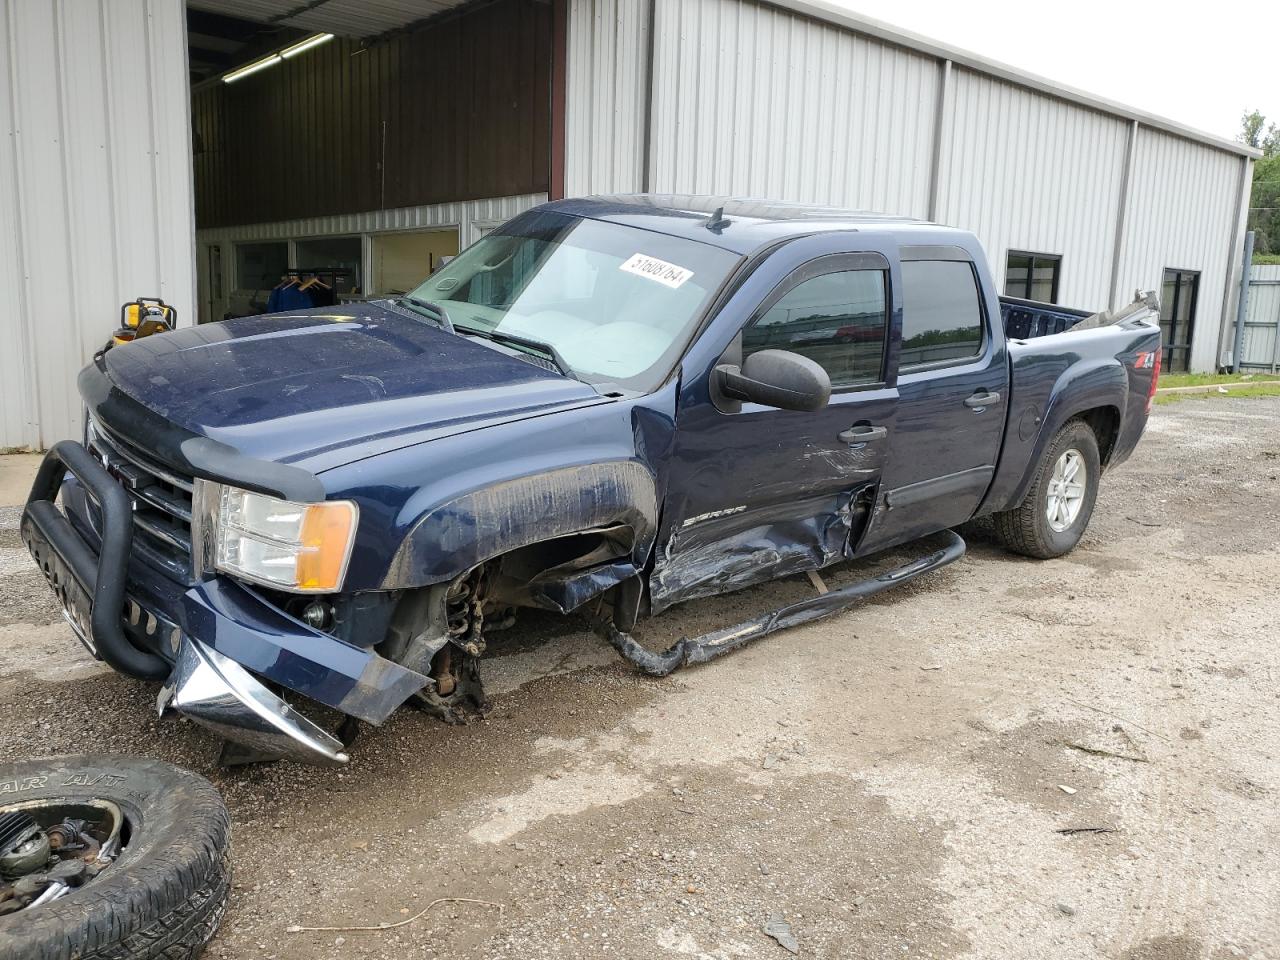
(1119, 128, 1245, 370)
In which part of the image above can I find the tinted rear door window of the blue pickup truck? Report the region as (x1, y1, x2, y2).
(899, 260, 983, 369)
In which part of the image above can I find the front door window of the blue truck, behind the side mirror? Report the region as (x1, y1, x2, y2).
(742, 270, 888, 389)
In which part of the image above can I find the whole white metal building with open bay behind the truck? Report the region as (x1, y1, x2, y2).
(0, 0, 1256, 448)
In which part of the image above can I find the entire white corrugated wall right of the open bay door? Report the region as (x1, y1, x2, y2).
(567, 0, 1248, 369)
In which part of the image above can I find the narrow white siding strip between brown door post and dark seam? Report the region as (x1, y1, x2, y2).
(564, 0, 657, 197)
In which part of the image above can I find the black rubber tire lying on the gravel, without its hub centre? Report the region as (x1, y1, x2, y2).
(0, 756, 230, 960)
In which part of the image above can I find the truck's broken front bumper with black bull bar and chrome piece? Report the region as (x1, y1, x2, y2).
(20, 442, 430, 763)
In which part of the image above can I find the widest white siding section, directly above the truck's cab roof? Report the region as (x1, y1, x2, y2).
(650, 0, 940, 216)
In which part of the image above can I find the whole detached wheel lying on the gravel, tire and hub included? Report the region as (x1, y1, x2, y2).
(0, 756, 230, 960)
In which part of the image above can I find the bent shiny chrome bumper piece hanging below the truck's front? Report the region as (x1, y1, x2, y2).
(156, 636, 347, 765)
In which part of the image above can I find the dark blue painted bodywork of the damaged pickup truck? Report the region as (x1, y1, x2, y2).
(37, 197, 1160, 719)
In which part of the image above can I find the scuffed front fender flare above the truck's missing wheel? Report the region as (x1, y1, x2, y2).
(381, 461, 658, 590)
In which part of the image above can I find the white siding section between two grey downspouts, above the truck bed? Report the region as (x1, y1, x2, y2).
(936, 69, 1129, 310)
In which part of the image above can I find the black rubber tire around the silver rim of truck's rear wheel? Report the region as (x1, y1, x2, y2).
(993, 420, 1102, 559)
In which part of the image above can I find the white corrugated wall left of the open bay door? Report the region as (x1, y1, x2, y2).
(0, 0, 195, 448)
